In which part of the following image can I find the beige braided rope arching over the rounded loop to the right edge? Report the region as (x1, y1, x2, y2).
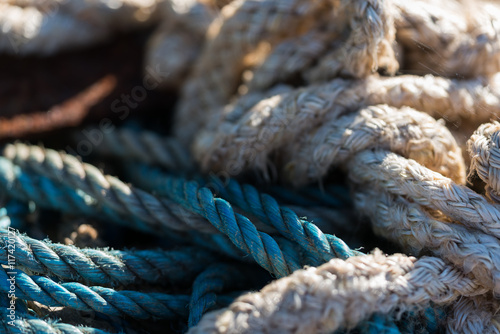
(193, 76, 488, 175)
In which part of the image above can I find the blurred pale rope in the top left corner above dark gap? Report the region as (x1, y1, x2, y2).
(0, 0, 159, 55)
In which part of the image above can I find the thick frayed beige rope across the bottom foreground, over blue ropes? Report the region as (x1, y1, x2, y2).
(190, 252, 487, 333)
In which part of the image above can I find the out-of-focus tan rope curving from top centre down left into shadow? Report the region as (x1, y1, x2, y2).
(175, 0, 338, 142)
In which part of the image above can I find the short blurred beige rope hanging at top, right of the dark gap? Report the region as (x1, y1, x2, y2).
(145, 0, 218, 89)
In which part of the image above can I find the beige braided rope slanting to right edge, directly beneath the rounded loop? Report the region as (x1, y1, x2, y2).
(348, 151, 500, 238)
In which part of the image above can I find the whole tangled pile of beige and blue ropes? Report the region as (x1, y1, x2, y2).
(0, 0, 500, 333)
